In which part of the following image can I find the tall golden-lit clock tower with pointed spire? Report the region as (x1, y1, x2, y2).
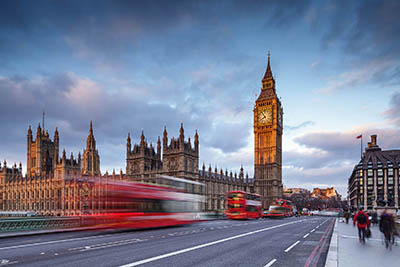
(253, 52, 283, 209)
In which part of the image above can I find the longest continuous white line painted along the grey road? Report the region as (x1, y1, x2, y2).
(120, 220, 303, 267)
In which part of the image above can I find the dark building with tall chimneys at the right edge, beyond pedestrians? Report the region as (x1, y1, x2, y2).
(348, 135, 400, 213)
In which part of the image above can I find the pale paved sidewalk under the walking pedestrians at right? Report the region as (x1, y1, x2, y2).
(325, 218, 400, 267)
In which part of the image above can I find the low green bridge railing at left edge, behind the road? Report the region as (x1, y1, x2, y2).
(0, 217, 81, 232)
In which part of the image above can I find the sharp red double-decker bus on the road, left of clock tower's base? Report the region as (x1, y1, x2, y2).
(225, 191, 262, 219)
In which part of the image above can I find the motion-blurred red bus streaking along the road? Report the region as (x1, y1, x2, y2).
(81, 177, 204, 229)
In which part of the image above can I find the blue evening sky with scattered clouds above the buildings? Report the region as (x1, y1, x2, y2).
(0, 0, 400, 195)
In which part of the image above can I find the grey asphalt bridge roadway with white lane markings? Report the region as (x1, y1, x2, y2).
(0, 216, 334, 267)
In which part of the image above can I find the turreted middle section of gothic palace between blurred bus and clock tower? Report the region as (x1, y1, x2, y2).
(126, 124, 253, 211)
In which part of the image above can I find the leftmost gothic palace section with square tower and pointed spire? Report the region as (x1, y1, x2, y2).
(0, 124, 104, 216)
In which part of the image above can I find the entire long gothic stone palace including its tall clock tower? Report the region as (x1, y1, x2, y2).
(0, 55, 283, 216)
